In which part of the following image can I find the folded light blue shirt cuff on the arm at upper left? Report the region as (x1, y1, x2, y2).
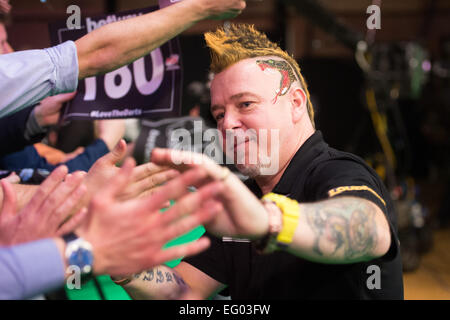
(45, 41, 79, 95)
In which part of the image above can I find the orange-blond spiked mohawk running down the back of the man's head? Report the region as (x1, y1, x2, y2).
(205, 24, 314, 126)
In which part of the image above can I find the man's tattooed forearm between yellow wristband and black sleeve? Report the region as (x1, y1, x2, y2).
(287, 197, 391, 263)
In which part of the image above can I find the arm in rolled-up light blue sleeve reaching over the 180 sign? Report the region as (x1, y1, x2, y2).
(0, 0, 245, 117)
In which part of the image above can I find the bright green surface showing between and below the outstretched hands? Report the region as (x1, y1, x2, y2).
(65, 201, 205, 300)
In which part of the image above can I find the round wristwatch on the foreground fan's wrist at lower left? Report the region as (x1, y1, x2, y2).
(66, 238, 94, 274)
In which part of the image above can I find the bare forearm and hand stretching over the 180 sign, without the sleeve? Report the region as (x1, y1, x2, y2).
(75, 0, 245, 79)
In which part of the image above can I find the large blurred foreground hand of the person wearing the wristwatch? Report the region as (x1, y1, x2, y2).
(77, 159, 220, 276)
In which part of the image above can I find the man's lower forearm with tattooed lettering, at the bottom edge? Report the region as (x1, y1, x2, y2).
(119, 262, 224, 300)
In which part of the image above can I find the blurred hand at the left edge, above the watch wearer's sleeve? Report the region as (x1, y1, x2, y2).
(0, 166, 86, 245)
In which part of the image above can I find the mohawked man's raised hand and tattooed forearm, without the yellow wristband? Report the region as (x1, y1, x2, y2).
(152, 149, 391, 264)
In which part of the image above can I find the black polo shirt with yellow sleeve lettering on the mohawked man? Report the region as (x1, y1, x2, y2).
(184, 131, 403, 299)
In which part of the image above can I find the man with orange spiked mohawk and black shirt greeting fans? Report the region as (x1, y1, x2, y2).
(113, 24, 403, 299)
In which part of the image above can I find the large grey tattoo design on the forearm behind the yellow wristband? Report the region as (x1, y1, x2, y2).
(304, 198, 377, 259)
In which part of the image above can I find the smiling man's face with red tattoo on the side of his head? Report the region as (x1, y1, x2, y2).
(211, 57, 295, 177)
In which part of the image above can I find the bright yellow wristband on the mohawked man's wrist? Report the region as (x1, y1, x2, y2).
(262, 193, 300, 245)
